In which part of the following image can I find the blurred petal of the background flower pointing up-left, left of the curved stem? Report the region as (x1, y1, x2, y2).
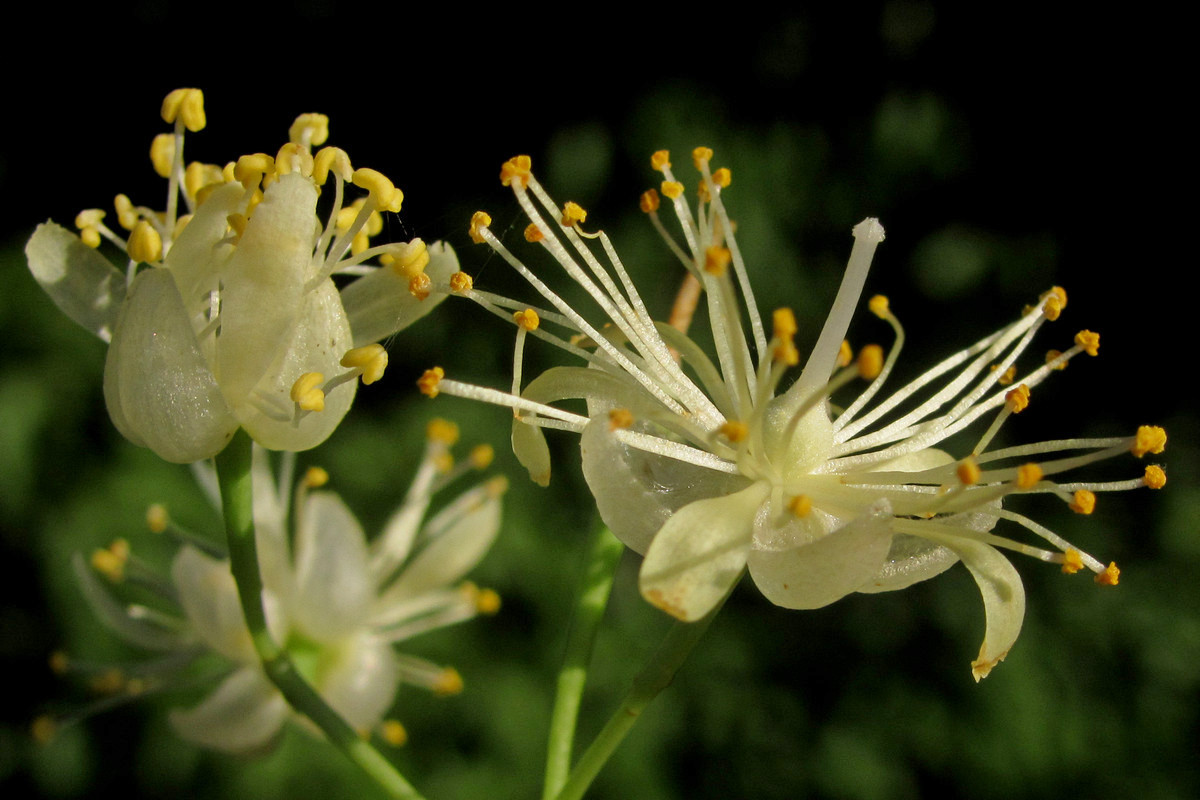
(170, 545, 257, 663)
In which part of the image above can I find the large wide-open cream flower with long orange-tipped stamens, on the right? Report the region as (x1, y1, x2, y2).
(419, 148, 1165, 679)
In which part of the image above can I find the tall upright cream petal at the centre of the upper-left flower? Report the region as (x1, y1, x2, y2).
(217, 173, 316, 408)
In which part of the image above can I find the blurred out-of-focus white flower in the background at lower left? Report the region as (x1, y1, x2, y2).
(65, 420, 505, 752)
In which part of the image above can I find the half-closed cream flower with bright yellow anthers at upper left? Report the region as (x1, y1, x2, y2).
(25, 89, 457, 463)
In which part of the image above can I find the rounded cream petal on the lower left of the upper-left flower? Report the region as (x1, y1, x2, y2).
(104, 269, 238, 463)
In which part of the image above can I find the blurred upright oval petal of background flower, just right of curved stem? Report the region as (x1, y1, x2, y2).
(292, 492, 372, 642)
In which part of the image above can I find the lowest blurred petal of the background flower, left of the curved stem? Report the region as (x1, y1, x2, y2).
(167, 667, 288, 753)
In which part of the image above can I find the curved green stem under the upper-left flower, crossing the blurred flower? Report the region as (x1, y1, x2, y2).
(216, 429, 424, 800)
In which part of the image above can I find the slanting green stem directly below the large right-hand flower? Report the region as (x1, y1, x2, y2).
(556, 601, 724, 800)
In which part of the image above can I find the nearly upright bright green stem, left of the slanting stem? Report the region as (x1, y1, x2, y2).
(542, 524, 625, 800)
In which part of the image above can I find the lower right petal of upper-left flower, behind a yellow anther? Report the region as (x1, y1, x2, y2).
(235, 281, 358, 450)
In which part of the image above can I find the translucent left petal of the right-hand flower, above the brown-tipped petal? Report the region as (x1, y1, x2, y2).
(580, 415, 749, 553)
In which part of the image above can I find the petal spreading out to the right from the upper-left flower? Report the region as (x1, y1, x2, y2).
(342, 242, 458, 347)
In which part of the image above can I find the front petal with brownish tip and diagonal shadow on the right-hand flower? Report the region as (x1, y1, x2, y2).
(638, 482, 770, 622)
